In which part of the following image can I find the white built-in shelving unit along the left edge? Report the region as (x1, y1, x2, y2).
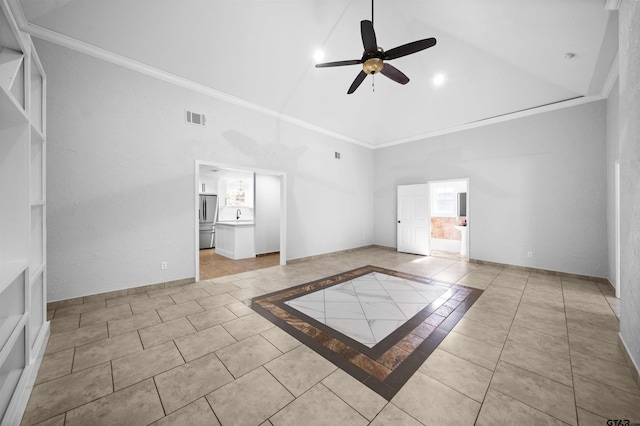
(0, 0, 49, 426)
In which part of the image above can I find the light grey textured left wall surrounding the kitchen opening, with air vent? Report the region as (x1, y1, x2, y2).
(41, 41, 373, 301)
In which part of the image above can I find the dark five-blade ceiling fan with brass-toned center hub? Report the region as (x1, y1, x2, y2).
(316, 0, 436, 94)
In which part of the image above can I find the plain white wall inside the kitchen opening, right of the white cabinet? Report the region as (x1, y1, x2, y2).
(255, 174, 280, 254)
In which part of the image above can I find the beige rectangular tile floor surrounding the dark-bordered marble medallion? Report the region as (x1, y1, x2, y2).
(23, 248, 640, 426)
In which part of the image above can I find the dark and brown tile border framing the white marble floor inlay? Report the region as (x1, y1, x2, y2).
(251, 266, 483, 401)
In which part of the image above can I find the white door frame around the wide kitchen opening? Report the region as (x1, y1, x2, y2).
(193, 160, 287, 282)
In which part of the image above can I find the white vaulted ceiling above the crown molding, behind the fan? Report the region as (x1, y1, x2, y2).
(20, 0, 618, 147)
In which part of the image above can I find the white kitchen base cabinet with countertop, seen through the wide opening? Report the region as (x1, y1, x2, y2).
(216, 221, 256, 260)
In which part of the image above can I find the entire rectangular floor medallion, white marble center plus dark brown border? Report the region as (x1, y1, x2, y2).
(251, 266, 483, 400)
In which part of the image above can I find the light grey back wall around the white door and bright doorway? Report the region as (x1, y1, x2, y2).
(374, 101, 607, 277)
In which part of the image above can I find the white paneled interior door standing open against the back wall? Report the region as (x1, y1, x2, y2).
(398, 183, 430, 255)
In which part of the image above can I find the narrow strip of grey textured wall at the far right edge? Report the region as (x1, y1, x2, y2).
(619, 0, 640, 378)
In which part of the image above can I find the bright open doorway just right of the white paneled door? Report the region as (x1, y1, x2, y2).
(429, 178, 469, 259)
